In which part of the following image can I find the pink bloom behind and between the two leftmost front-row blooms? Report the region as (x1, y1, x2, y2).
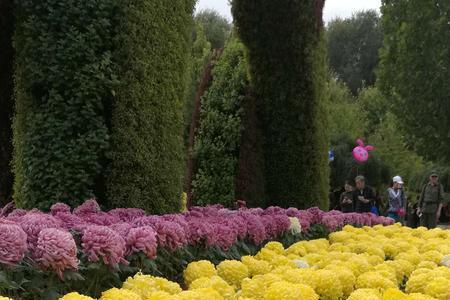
(20, 212, 62, 251)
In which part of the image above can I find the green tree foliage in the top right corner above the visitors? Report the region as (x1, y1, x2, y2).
(379, 0, 450, 163)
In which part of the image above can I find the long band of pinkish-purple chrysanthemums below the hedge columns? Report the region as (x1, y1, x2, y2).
(0, 200, 393, 276)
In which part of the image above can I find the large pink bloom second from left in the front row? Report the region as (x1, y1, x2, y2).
(34, 228, 78, 278)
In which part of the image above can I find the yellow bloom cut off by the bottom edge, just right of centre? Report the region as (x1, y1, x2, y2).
(264, 281, 319, 300)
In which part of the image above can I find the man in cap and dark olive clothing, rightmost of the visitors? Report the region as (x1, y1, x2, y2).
(418, 172, 444, 229)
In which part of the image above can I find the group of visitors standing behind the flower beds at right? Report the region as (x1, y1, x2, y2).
(330, 172, 450, 228)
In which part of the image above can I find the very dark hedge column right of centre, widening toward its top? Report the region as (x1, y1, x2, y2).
(232, 0, 329, 207)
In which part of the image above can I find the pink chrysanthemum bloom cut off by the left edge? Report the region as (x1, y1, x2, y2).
(0, 223, 27, 265)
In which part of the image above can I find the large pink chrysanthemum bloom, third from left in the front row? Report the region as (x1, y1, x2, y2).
(81, 225, 127, 266)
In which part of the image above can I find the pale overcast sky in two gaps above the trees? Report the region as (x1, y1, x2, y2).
(197, 0, 381, 22)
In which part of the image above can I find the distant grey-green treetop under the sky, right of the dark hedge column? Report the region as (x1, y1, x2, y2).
(327, 10, 383, 94)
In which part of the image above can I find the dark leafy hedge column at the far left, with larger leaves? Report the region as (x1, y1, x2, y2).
(14, 0, 114, 209)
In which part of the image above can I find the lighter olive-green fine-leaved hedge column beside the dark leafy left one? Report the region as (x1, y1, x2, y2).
(107, 0, 195, 213)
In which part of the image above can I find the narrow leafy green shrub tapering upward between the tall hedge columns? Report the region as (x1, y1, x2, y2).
(193, 40, 248, 207)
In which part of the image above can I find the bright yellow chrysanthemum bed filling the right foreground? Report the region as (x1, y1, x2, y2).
(62, 224, 450, 300)
